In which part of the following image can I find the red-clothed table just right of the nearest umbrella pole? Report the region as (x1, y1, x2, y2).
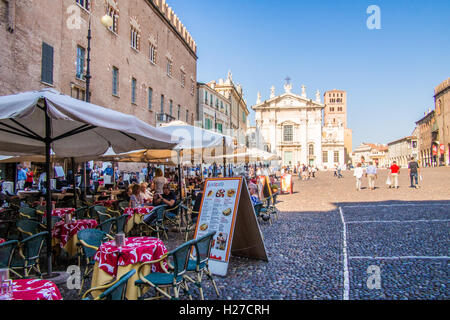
(52, 219, 98, 257)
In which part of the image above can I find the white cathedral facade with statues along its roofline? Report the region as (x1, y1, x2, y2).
(252, 83, 345, 170)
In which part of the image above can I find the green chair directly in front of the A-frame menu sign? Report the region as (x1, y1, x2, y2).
(184, 231, 220, 300)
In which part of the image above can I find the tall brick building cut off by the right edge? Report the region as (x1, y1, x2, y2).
(434, 78, 450, 166)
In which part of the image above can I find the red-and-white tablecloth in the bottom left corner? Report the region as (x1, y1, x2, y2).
(12, 279, 62, 300)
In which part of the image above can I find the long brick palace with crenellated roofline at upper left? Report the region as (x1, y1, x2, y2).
(0, 0, 197, 125)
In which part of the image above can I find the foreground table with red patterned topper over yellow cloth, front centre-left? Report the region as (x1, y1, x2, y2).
(91, 237, 168, 300)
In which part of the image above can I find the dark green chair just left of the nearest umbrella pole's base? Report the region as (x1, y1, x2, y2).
(10, 231, 48, 278)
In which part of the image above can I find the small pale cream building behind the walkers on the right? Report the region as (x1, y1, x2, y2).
(388, 136, 419, 168)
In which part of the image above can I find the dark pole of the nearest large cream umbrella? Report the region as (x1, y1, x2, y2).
(44, 100, 53, 277)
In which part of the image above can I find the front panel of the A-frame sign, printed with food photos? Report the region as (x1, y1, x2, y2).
(195, 178, 241, 263)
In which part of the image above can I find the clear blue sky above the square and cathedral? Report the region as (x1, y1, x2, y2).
(167, 0, 450, 147)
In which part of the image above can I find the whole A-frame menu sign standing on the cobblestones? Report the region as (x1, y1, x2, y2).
(194, 178, 268, 276)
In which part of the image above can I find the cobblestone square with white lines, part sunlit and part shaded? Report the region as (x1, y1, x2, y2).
(60, 168, 450, 300)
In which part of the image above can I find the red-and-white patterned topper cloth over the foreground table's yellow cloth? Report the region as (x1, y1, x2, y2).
(94, 237, 167, 276)
